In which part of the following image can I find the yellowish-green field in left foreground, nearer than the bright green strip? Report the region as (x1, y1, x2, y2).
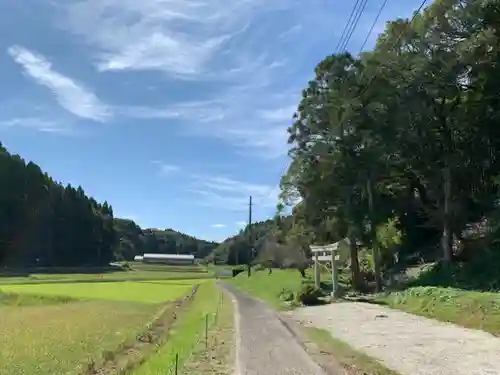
(0, 301, 158, 375)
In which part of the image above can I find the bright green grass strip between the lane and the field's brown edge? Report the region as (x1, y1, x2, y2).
(134, 282, 225, 375)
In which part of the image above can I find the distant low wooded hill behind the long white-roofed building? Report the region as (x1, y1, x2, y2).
(115, 219, 218, 260)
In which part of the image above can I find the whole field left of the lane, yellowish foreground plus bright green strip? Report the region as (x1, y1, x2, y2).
(0, 266, 217, 375)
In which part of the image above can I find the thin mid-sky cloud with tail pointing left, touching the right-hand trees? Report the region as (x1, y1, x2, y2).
(134, 85, 300, 159)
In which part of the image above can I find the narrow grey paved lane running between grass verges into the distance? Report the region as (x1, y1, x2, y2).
(223, 284, 324, 375)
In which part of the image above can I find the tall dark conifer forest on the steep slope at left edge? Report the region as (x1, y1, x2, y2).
(0, 144, 115, 266)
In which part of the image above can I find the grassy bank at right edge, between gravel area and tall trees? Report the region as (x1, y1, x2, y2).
(375, 287, 500, 335)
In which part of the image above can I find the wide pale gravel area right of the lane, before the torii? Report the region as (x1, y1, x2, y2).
(287, 302, 500, 375)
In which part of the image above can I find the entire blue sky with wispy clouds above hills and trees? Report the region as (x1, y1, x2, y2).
(0, 0, 420, 240)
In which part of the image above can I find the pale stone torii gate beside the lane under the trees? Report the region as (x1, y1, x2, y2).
(310, 238, 350, 297)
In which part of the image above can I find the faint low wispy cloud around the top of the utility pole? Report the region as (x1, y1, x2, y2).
(189, 176, 279, 211)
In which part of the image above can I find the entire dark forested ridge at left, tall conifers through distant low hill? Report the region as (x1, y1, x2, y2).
(0, 144, 217, 267)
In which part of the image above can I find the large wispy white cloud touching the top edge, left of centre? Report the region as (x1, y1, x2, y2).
(65, 0, 286, 78)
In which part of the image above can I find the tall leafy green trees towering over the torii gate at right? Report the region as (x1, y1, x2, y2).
(281, 0, 500, 287)
